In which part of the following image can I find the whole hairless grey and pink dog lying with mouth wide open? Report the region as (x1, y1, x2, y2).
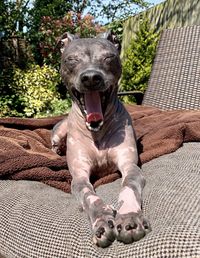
(52, 32, 151, 247)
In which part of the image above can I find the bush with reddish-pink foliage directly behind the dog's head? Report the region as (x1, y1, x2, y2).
(34, 12, 104, 68)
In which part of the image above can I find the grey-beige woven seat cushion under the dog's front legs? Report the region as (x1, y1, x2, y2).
(0, 143, 200, 258)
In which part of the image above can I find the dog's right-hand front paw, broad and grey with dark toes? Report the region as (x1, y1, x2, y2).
(115, 212, 151, 244)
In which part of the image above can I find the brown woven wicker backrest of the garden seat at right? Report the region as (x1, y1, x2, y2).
(143, 25, 200, 110)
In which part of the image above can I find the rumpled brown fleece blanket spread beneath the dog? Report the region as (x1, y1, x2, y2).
(0, 105, 200, 192)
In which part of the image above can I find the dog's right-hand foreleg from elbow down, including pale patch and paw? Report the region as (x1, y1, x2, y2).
(116, 164, 150, 244)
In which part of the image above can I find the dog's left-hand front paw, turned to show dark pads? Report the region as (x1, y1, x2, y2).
(93, 216, 116, 248)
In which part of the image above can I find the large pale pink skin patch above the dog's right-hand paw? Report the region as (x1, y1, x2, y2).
(118, 186, 141, 214)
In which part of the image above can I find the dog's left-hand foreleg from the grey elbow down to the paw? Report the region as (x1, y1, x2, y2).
(72, 172, 115, 247)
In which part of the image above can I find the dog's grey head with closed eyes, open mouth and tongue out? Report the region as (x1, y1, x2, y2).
(60, 32, 121, 131)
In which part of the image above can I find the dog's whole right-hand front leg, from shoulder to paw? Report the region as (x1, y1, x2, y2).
(112, 127, 151, 244)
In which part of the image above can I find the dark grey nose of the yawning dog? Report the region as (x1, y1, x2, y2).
(80, 70, 103, 89)
